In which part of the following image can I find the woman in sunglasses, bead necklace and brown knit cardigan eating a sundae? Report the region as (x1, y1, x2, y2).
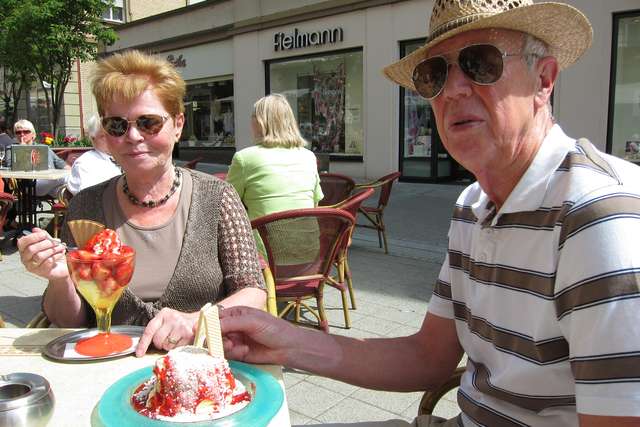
(18, 50, 266, 356)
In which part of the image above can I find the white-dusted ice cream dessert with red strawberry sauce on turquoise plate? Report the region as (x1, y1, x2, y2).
(131, 346, 251, 422)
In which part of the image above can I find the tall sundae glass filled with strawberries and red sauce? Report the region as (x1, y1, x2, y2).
(67, 223, 135, 357)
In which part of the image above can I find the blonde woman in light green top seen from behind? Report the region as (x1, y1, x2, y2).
(226, 94, 324, 252)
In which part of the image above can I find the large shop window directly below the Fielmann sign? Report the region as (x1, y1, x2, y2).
(267, 50, 363, 157)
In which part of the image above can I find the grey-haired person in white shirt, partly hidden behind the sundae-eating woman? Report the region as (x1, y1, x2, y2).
(67, 113, 122, 196)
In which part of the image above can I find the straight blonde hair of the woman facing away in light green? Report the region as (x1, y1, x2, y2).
(253, 93, 307, 148)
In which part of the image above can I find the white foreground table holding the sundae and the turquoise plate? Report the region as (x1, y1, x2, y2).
(0, 328, 291, 427)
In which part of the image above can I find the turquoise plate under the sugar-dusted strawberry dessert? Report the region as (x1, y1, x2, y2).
(91, 360, 284, 427)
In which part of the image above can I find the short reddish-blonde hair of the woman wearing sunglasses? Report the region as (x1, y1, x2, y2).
(91, 50, 186, 117)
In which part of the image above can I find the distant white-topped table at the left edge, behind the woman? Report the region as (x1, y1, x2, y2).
(0, 169, 71, 228)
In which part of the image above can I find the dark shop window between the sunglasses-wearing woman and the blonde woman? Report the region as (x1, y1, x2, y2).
(180, 79, 235, 147)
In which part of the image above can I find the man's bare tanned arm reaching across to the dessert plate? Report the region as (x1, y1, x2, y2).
(221, 307, 463, 391)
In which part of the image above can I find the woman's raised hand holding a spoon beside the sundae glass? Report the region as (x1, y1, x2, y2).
(18, 228, 69, 280)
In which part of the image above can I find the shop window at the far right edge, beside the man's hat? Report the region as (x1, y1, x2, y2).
(608, 11, 640, 162)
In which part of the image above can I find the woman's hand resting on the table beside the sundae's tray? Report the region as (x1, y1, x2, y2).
(136, 307, 200, 357)
